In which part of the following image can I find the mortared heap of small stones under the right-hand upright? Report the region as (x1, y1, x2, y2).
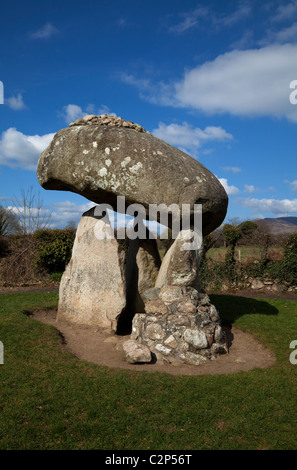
(131, 286, 228, 365)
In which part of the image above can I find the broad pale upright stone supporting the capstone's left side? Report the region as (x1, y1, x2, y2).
(58, 208, 126, 330)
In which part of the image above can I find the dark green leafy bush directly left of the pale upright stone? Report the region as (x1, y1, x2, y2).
(34, 228, 75, 274)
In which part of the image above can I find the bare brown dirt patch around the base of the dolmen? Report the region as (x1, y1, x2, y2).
(32, 310, 276, 375)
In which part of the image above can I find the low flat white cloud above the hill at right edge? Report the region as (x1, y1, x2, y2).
(239, 198, 297, 215)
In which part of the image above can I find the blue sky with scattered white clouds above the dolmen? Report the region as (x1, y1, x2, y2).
(0, 0, 297, 228)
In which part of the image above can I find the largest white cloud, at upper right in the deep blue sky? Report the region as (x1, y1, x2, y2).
(171, 44, 297, 122)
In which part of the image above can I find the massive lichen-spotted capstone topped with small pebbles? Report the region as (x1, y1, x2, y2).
(37, 115, 228, 235)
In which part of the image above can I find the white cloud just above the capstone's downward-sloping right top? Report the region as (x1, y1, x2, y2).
(152, 122, 233, 155)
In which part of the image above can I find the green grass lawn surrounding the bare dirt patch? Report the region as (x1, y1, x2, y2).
(0, 293, 297, 450)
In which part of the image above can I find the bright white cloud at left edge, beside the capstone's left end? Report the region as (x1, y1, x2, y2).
(0, 127, 55, 170)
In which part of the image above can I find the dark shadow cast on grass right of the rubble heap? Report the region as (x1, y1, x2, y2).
(209, 294, 279, 324)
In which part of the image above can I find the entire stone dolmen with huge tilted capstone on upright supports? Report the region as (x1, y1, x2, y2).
(37, 115, 228, 365)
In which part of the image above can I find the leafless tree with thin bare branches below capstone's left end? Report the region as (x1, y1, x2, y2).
(10, 186, 52, 235)
